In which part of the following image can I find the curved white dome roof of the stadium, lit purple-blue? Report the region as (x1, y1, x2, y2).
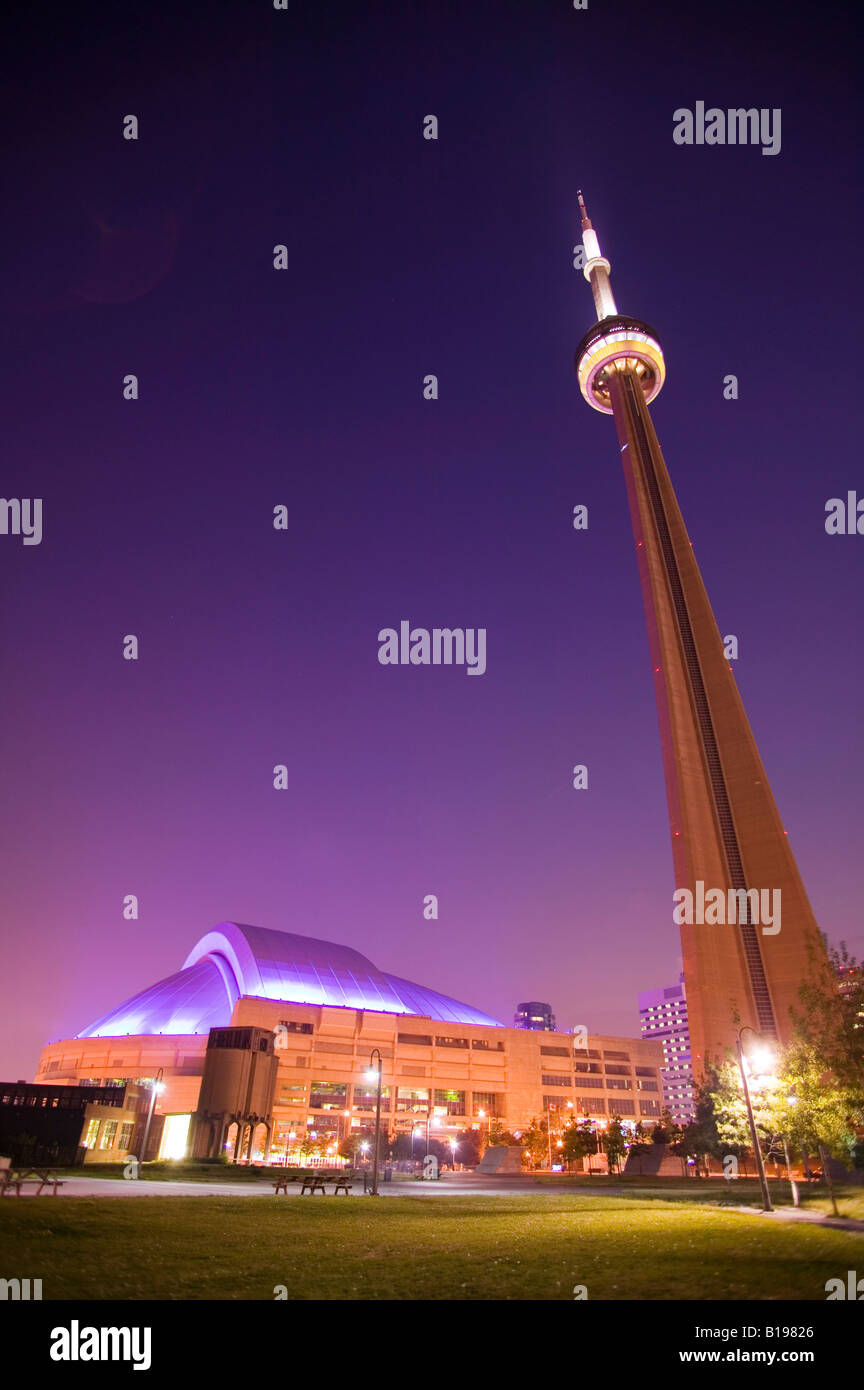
(76, 922, 501, 1038)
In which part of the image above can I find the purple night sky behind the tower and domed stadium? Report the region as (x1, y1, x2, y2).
(0, 0, 864, 1080)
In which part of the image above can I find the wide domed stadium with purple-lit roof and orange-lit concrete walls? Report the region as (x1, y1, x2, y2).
(35, 922, 663, 1165)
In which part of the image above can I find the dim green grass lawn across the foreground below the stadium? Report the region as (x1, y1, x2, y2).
(0, 1193, 864, 1301)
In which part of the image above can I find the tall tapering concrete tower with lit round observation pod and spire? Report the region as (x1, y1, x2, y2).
(575, 193, 824, 1076)
